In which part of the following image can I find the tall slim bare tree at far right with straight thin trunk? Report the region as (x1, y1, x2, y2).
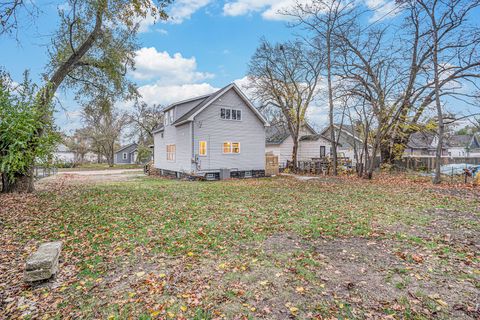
(410, 0, 480, 184)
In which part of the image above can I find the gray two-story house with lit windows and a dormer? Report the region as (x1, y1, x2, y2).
(154, 84, 268, 179)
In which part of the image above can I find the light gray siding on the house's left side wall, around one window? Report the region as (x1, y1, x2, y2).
(154, 123, 192, 173)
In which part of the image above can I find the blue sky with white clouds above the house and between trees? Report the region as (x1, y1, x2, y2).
(0, 0, 448, 133)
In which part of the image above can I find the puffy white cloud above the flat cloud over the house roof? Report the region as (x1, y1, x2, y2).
(130, 47, 214, 85)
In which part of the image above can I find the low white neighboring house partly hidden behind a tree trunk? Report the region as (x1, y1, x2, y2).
(265, 124, 331, 168)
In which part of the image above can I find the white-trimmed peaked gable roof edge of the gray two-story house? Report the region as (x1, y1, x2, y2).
(173, 83, 269, 126)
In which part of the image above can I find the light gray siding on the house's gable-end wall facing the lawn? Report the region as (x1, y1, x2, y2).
(193, 89, 265, 172)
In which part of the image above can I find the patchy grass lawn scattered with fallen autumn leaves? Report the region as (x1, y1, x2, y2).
(0, 177, 480, 319)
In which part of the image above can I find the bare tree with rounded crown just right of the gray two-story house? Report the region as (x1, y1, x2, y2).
(248, 40, 324, 169)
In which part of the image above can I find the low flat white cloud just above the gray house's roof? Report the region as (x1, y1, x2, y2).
(138, 83, 218, 105)
